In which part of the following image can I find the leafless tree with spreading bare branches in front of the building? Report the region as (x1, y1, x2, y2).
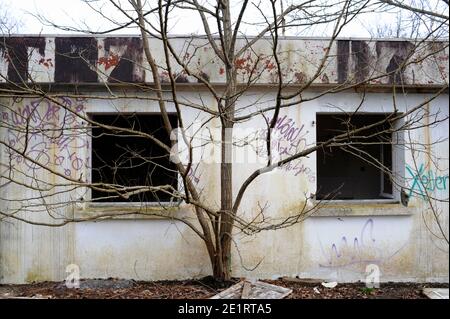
(0, 0, 448, 280)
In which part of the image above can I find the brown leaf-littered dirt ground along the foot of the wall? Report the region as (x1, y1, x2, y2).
(0, 278, 448, 299)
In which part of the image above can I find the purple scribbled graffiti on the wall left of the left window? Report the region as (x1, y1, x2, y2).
(1, 97, 90, 178)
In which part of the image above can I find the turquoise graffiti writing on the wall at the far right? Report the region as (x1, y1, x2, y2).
(406, 163, 448, 199)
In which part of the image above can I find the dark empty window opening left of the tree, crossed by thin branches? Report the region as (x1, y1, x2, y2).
(91, 114, 178, 202)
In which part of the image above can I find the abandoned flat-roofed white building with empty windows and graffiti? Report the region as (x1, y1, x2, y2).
(0, 35, 449, 283)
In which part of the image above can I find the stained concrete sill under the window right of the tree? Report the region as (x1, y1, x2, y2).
(312, 199, 414, 217)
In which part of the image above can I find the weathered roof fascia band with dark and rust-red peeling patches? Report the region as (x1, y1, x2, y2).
(0, 36, 449, 86)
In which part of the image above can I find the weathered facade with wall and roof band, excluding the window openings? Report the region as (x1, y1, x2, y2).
(0, 36, 449, 289)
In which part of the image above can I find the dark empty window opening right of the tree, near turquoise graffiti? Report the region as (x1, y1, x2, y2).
(316, 114, 393, 200)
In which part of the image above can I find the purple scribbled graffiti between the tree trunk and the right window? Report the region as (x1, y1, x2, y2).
(257, 115, 316, 182)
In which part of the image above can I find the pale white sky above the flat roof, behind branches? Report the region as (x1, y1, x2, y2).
(0, 0, 446, 37)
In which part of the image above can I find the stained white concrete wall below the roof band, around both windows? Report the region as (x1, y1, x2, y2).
(0, 90, 449, 283)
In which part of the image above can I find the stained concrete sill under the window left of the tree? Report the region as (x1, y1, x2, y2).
(74, 202, 185, 220)
